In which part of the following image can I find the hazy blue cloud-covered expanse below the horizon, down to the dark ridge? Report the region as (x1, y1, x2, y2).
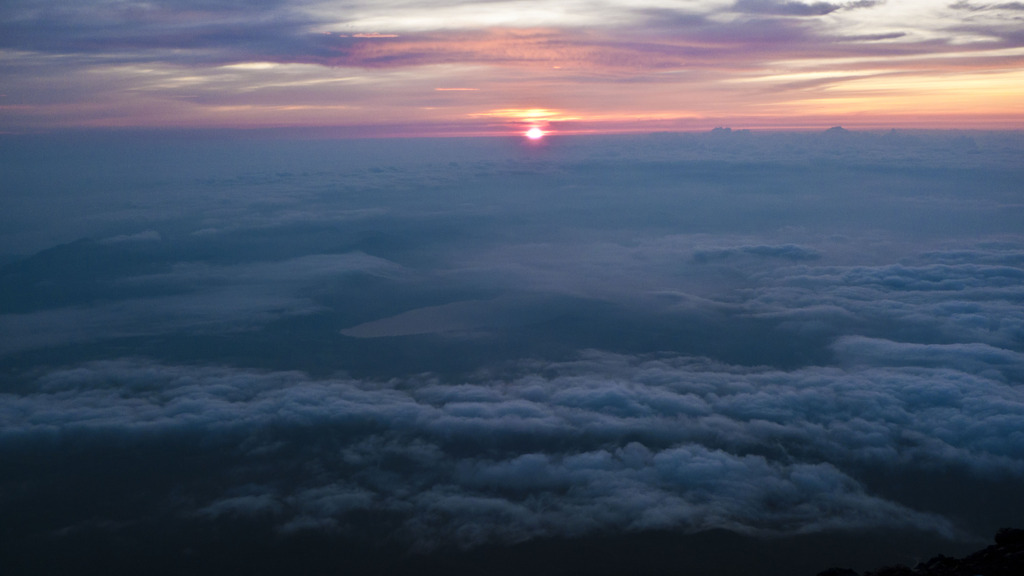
(0, 128, 1024, 576)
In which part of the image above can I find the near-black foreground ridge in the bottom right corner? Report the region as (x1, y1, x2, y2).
(818, 528, 1024, 576)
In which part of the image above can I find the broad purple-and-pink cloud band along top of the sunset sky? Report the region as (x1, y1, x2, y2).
(4, 2, 999, 73)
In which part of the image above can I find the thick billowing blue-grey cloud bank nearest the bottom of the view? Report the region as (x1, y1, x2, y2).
(0, 338, 1024, 545)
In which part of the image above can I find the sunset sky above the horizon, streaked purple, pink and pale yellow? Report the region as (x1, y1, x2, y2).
(0, 0, 1024, 136)
